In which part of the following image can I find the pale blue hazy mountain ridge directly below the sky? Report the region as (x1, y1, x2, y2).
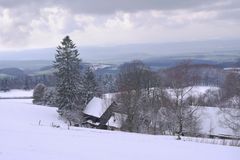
(0, 40, 240, 64)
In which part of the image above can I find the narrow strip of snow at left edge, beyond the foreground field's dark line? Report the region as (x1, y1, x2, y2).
(0, 89, 33, 98)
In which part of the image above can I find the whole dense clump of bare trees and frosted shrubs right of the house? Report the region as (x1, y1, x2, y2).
(117, 61, 175, 134)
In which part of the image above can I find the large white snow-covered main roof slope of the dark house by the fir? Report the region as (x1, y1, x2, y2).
(83, 97, 112, 118)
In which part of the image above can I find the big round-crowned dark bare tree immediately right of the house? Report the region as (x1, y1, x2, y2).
(117, 60, 157, 132)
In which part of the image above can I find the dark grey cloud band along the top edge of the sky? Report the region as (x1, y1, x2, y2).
(0, 0, 240, 14)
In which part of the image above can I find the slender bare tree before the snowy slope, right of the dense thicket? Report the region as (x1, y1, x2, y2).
(167, 62, 199, 139)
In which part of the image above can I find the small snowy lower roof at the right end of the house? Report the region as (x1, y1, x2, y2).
(106, 112, 127, 128)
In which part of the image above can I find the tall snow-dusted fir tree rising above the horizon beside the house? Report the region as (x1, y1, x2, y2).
(54, 36, 81, 112)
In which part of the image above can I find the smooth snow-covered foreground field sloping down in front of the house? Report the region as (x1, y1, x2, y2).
(0, 99, 240, 160)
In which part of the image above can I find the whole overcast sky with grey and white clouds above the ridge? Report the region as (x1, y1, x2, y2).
(0, 0, 240, 50)
